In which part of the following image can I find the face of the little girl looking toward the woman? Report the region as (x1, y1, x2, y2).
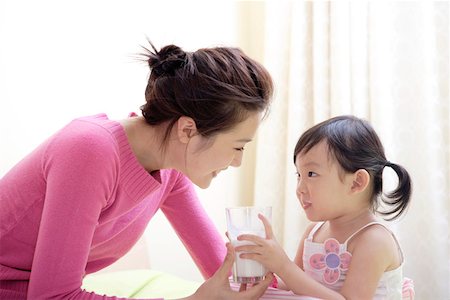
(295, 141, 352, 221)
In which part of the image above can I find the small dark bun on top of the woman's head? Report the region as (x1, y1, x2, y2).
(148, 45, 186, 76)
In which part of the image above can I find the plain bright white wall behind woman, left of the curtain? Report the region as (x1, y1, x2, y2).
(0, 0, 243, 280)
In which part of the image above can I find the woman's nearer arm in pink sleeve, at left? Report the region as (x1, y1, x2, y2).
(28, 123, 144, 299)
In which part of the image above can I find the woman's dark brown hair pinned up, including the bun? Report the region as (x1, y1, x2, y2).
(141, 41, 273, 147)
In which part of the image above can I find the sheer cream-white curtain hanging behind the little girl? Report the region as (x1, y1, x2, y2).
(240, 1, 450, 299)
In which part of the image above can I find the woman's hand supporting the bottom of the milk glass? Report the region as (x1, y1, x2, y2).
(185, 243, 273, 300)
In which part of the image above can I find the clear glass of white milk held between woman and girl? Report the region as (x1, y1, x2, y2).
(226, 206, 272, 283)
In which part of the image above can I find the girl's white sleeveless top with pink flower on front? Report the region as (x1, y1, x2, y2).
(303, 222, 404, 300)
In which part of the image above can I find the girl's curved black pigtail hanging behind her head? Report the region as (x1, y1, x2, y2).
(379, 162, 412, 221)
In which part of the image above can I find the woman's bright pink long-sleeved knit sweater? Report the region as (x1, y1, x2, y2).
(0, 114, 226, 299)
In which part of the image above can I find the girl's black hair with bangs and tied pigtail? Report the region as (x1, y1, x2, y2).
(294, 116, 411, 220)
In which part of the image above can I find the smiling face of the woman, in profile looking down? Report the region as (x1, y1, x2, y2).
(185, 113, 262, 188)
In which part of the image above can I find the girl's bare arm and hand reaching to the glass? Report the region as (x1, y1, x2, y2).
(236, 216, 393, 299)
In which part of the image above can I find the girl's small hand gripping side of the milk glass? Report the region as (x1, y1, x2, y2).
(235, 214, 293, 274)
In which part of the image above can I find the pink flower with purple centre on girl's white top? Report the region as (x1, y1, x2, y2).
(309, 238, 352, 285)
